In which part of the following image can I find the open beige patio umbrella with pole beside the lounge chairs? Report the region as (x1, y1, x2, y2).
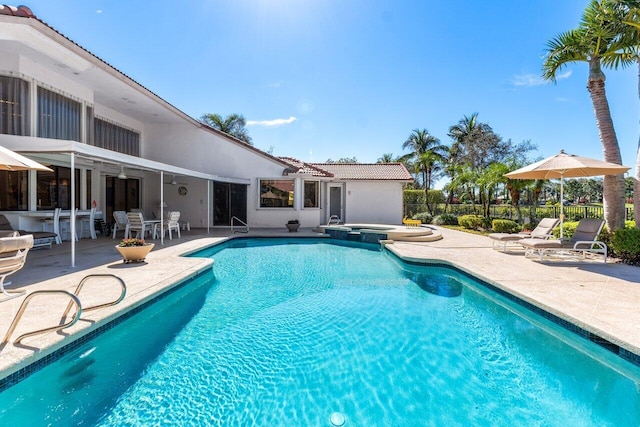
(504, 150, 629, 237)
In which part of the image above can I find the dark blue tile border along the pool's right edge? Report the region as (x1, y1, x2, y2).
(396, 251, 640, 366)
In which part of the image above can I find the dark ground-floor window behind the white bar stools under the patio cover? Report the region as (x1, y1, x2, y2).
(36, 166, 91, 210)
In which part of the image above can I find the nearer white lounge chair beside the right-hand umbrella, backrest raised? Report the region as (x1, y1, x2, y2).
(518, 219, 607, 263)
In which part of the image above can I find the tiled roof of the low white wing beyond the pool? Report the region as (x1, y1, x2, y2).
(311, 163, 413, 181)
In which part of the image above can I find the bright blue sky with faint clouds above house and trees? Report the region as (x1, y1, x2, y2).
(26, 0, 639, 187)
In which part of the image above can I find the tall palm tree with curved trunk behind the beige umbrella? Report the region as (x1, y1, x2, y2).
(542, 0, 628, 231)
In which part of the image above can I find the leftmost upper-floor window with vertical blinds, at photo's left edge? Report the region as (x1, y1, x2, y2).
(0, 76, 29, 136)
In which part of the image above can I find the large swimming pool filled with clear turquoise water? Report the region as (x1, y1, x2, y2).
(0, 239, 640, 426)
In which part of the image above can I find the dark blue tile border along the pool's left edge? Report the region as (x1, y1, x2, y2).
(0, 269, 209, 393)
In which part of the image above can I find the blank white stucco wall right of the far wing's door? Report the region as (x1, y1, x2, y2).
(345, 181, 403, 224)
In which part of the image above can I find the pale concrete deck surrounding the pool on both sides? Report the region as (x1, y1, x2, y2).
(0, 227, 640, 379)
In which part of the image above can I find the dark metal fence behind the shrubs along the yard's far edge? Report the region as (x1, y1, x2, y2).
(404, 203, 633, 222)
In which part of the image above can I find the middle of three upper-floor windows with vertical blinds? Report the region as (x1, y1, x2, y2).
(38, 87, 81, 141)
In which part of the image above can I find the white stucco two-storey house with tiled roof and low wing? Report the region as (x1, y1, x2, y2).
(0, 6, 411, 239)
